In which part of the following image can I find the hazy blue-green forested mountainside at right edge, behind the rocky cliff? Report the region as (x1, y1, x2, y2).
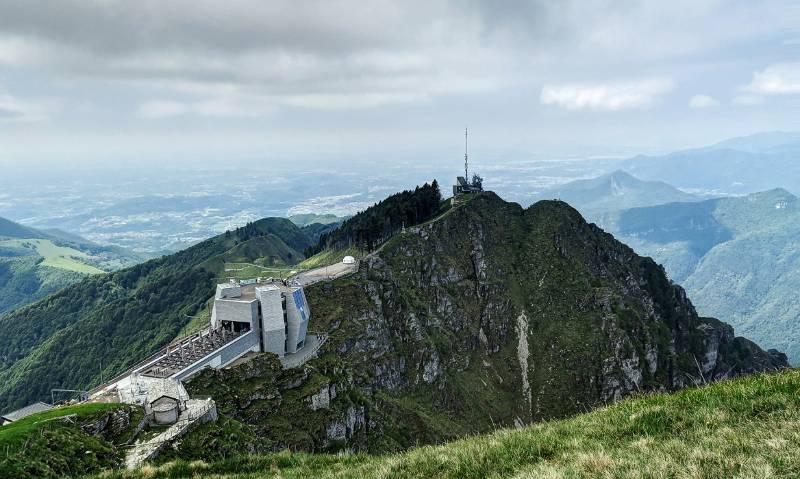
(601, 189, 800, 363)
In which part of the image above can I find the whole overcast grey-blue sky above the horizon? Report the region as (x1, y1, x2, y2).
(0, 0, 800, 168)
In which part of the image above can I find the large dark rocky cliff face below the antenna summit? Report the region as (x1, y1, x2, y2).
(183, 193, 787, 452)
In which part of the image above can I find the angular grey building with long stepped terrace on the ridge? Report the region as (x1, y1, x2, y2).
(92, 278, 318, 408)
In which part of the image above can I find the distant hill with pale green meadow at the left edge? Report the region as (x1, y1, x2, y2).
(0, 218, 149, 315)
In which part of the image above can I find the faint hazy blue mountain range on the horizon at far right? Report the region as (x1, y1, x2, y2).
(620, 132, 800, 195)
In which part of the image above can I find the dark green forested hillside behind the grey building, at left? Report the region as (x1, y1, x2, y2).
(0, 218, 310, 410)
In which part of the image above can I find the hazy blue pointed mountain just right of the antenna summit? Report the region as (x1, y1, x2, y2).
(536, 170, 697, 221)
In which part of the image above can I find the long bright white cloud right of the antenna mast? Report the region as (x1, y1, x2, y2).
(539, 78, 672, 111)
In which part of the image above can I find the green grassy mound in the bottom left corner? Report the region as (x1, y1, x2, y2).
(0, 404, 144, 478)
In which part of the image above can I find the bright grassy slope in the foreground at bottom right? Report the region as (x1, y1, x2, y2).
(104, 370, 800, 478)
